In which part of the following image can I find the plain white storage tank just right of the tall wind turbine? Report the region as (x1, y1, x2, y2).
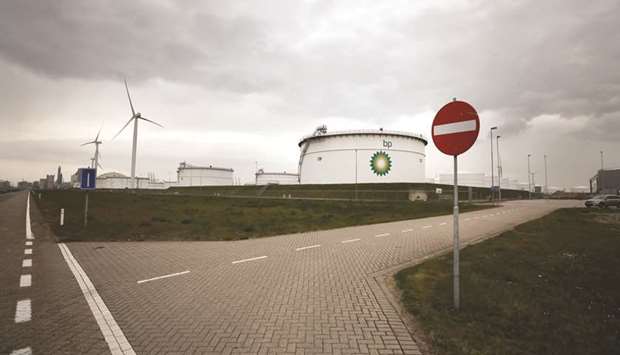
(176, 162, 234, 186)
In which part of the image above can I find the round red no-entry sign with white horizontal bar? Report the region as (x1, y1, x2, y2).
(432, 101, 480, 155)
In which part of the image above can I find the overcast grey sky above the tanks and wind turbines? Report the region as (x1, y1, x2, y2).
(0, 0, 620, 187)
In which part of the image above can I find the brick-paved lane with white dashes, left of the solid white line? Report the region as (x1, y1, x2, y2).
(0, 192, 109, 354)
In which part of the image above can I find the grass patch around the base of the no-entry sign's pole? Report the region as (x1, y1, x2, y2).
(396, 209, 620, 354)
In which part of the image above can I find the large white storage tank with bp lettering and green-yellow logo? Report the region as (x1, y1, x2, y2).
(299, 126, 428, 184)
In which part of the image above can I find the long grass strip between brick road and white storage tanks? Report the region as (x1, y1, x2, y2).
(37, 190, 484, 241)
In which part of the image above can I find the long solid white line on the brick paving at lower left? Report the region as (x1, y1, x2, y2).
(58, 243, 135, 355)
